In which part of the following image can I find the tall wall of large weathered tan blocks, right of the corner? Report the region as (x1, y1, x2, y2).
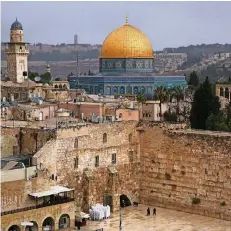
(140, 126, 231, 220)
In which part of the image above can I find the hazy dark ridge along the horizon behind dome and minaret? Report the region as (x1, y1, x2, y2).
(1, 43, 231, 61)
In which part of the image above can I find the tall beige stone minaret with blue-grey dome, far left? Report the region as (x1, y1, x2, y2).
(5, 18, 29, 83)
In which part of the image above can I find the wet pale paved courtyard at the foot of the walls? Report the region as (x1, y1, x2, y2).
(81, 205, 231, 231)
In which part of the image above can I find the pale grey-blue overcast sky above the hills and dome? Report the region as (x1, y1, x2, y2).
(1, 2, 231, 50)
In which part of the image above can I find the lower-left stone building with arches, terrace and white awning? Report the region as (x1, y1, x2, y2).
(1, 128, 75, 231)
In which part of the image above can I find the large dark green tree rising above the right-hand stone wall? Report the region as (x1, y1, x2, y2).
(190, 77, 221, 129)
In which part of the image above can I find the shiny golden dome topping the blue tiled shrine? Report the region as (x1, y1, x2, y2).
(100, 20, 154, 58)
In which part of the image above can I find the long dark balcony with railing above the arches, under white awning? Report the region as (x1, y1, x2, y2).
(1, 197, 74, 216)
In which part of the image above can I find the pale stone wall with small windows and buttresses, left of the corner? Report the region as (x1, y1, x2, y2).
(33, 121, 140, 212)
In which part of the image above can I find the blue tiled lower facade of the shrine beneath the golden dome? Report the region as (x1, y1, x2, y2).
(68, 73, 187, 97)
